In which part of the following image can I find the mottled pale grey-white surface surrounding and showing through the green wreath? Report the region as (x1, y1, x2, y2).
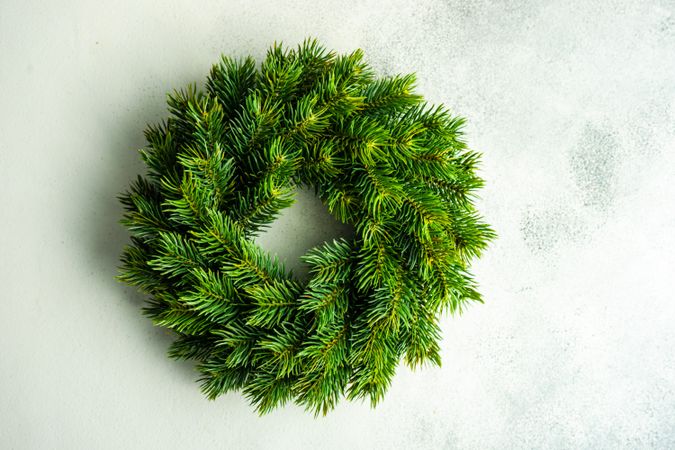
(0, 0, 675, 449)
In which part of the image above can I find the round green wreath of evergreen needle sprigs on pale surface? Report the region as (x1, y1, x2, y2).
(118, 40, 494, 414)
